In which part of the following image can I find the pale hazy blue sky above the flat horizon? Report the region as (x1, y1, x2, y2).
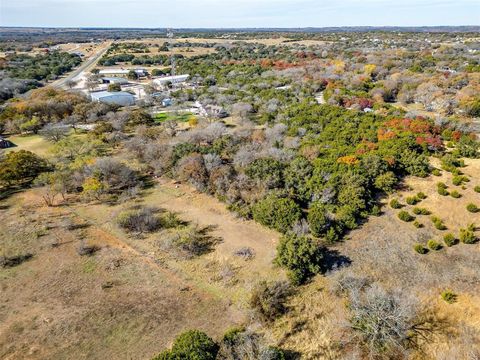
(0, 0, 480, 27)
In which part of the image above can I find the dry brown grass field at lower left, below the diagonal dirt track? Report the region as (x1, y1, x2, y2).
(0, 190, 242, 359)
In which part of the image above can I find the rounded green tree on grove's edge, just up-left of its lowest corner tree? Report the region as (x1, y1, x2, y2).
(252, 195, 302, 233)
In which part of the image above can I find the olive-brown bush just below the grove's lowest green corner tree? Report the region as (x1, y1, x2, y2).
(250, 281, 291, 323)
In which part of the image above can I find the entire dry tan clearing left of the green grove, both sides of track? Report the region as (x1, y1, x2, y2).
(0, 178, 283, 359)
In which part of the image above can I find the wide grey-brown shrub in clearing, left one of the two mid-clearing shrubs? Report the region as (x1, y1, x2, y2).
(117, 207, 162, 234)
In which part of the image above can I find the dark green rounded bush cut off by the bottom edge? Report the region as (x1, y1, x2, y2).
(153, 330, 218, 360)
